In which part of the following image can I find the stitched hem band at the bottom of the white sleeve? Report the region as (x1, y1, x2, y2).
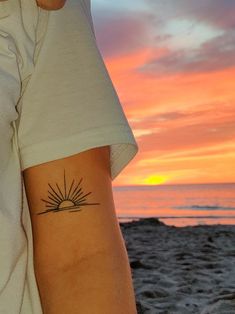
(20, 125, 138, 181)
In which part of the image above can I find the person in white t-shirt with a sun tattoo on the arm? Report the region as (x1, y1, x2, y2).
(0, 0, 138, 314)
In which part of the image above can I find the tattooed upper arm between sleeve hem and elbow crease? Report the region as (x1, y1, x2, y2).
(23, 146, 124, 271)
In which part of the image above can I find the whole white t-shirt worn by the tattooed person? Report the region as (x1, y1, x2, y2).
(0, 0, 138, 314)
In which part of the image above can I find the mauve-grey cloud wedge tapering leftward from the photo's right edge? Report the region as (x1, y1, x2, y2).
(136, 30, 235, 76)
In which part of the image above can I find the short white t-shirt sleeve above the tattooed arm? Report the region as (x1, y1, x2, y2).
(18, 0, 138, 180)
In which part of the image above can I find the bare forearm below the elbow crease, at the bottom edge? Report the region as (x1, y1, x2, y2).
(35, 239, 137, 314)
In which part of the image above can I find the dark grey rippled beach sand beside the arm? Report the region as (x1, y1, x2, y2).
(120, 218, 235, 314)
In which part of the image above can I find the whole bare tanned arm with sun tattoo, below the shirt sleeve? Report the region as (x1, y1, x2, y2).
(24, 146, 137, 314)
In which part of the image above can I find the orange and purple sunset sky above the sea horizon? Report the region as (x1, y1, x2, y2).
(92, 0, 235, 186)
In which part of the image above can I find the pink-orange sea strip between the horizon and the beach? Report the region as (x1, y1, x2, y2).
(113, 183, 235, 227)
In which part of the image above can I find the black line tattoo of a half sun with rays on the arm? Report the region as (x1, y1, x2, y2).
(37, 169, 100, 215)
